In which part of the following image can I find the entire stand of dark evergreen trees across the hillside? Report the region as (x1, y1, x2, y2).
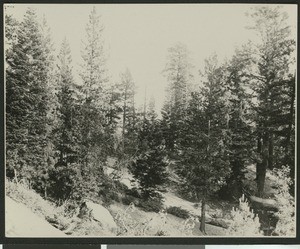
(5, 7, 296, 235)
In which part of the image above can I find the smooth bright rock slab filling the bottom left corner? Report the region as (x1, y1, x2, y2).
(5, 197, 67, 237)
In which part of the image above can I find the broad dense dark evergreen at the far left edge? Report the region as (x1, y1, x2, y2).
(6, 8, 51, 191)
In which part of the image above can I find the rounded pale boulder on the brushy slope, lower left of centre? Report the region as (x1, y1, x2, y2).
(78, 201, 117, 230)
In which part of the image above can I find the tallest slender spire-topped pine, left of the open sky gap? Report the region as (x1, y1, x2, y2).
(79, 7, 110, 181)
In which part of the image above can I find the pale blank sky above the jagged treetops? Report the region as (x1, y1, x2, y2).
(6, 4, 297, 109)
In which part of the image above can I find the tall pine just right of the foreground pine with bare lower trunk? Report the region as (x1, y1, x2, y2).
(221, 49, 254, 199)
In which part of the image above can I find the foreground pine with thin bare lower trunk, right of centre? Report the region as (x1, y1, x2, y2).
(177, 57, 230, 233)
